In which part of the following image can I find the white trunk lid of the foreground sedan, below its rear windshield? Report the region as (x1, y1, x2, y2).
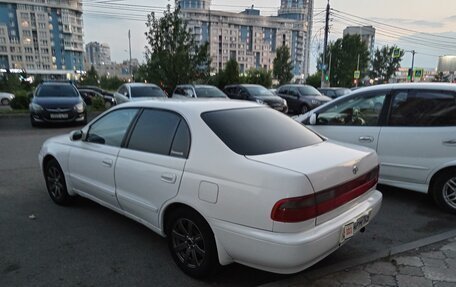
(246, 141, 378, 192)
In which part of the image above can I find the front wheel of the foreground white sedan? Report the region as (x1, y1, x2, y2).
(44, 159, 74, 205)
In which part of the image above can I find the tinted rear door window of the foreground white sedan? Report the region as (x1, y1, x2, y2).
(128, 110, 180, 155)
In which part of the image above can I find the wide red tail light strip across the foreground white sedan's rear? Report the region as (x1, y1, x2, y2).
(271, 166, 379, 223)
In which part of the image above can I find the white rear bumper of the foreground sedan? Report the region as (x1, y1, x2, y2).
(210, 189, 382, 274)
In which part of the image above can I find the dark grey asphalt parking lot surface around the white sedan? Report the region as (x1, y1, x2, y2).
(0, 116, 455, 286)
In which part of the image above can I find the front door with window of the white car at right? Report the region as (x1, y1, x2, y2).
(307, 90, 389, 150)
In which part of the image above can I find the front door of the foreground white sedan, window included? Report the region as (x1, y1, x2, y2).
(68, 108, 138, 207)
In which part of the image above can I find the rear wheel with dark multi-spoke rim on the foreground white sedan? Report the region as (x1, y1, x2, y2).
(166, 208, 220, 279)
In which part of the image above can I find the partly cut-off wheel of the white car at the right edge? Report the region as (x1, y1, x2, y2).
(431, 169, 456, 213)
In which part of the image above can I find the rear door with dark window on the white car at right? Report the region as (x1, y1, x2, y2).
(377, 89, 456, 188)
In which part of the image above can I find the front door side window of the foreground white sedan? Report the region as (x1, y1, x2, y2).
(86, 109, 138, 147)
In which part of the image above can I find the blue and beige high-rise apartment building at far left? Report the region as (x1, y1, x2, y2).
(0, 0, 84, 79)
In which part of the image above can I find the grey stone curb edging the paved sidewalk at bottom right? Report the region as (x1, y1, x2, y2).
(260, 230, 456, 287)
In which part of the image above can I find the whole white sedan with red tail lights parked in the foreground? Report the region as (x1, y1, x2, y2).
(39, 100, 382, 278)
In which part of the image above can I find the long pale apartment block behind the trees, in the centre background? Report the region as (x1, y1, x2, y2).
(180, 0, 313, 80)
